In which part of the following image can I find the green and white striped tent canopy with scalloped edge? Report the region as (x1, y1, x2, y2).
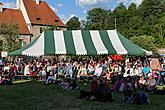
(9, 30, 151, 56)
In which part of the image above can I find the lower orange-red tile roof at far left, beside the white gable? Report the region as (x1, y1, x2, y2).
(0, 8, 30, 35)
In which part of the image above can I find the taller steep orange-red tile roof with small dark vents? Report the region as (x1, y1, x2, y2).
(23, 0, 66, 27)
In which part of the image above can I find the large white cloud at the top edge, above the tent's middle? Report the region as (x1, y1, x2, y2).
(76, 0, 112, 10)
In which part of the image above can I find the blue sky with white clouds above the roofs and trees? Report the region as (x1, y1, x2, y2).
(0, 0, 142, 22)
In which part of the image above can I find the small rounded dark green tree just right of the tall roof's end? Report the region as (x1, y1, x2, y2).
(66, 16, 81, 30)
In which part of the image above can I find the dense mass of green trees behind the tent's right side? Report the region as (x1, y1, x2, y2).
(66, 0, 165, 51)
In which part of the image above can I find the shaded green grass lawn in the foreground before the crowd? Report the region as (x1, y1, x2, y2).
(0, 81, 165, 110)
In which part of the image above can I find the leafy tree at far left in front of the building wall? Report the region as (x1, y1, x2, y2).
(0, 23, 20, 51)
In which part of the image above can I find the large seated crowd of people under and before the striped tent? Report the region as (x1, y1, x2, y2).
(0, 56, 165, 103)
